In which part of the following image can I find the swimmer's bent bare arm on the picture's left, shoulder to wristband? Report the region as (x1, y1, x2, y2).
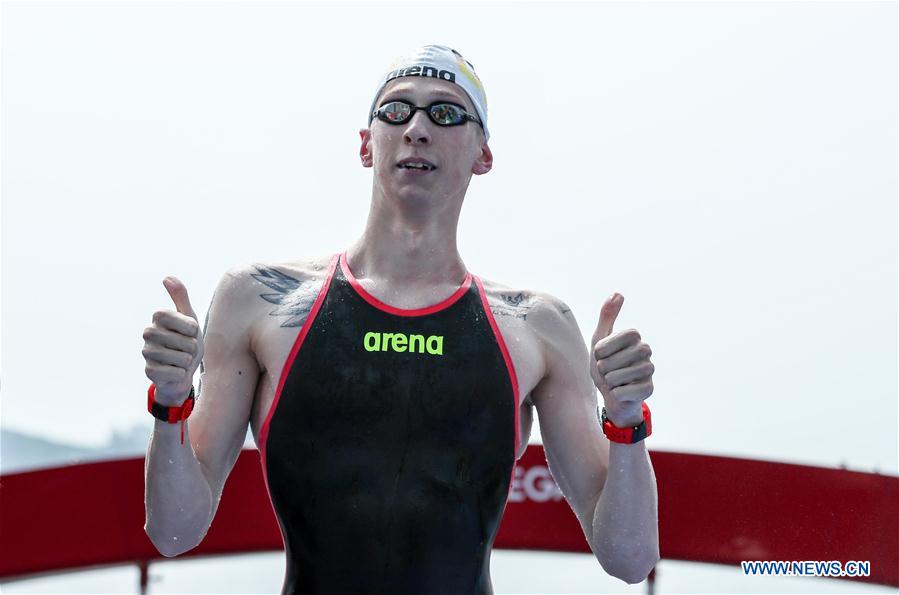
(144, 267, 260, 557)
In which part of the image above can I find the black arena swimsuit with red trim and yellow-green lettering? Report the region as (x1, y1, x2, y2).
(260, 254, 519, 594)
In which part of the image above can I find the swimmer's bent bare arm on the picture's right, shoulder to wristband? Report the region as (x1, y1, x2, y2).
(529, 295, 658, 584)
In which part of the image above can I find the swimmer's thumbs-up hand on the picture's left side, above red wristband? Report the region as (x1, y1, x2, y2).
(142, 277, 203, 407)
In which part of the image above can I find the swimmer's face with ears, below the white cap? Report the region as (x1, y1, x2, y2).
(360, 77, 493, 207)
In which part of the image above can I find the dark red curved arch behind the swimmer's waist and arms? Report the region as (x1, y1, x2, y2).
(0, 444, 899, 587)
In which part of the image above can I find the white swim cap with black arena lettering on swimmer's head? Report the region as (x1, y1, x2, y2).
(368, 45, 490, 139)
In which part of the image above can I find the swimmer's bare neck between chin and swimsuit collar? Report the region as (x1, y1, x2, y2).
(347, 192, 466, 288)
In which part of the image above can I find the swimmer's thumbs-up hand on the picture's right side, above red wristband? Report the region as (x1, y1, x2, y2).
(590, 293, 655, 427)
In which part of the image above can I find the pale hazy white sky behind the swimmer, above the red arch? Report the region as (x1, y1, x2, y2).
(0, 2, 897, 590)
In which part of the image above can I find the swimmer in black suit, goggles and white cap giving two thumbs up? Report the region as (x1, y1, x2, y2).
(143, 45, 659, 594)
